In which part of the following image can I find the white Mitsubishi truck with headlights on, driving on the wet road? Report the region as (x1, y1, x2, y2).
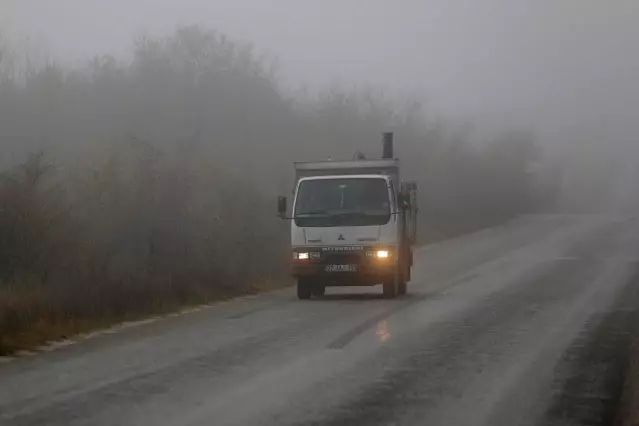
(278, 133, 417, 299)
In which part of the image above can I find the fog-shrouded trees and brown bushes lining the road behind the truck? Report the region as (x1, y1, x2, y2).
(0, 27, 558, 354)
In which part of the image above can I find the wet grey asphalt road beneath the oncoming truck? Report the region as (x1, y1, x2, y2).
(0, 216, 639, 426)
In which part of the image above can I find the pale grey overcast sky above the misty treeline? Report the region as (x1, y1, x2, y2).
(0, 0, 639, 145)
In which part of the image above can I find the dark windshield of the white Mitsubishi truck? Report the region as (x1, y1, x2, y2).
(295, 178, 391, 227)
